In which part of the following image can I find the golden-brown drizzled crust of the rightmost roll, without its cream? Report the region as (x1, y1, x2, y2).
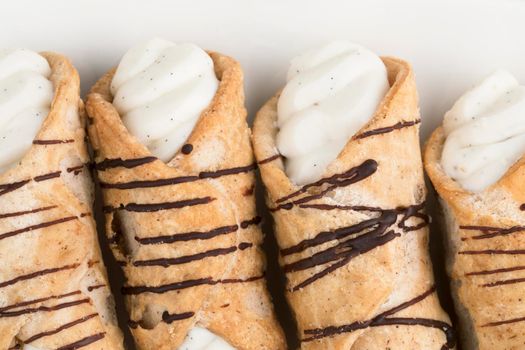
(425, 127, 525, 349)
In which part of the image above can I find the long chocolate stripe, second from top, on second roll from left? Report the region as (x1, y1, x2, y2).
(100, 164, 257, 190)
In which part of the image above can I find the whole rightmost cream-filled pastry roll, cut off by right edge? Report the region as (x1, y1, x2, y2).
(425, 71, 525, 349)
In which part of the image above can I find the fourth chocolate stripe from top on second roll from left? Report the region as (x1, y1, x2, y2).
(135, 216, 261, 245)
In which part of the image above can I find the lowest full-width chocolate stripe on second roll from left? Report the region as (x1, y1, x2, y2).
(122, 275, 264, 295)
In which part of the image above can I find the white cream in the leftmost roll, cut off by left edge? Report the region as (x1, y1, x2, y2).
(0, 49, 54, 173)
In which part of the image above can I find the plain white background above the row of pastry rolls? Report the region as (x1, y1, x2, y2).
(0, 0, 525, 138)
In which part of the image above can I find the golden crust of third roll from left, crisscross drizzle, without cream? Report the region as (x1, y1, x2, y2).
(253, 58, 454, 349)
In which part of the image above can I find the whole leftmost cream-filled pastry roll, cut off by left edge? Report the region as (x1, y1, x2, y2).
(0, 49, 123, 350)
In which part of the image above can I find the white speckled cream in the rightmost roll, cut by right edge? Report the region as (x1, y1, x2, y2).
(441, 71, 525, 192)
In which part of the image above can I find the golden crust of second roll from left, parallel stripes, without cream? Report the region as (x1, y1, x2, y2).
(87, 53, 285, 350)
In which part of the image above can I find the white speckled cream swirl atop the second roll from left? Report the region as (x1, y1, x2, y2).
(111, 38, 219, 162)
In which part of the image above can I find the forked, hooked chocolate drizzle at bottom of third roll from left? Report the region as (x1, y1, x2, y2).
(301, 287, 456, 349)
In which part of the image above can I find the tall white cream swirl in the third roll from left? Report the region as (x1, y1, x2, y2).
(276, 41, 390, 185)
